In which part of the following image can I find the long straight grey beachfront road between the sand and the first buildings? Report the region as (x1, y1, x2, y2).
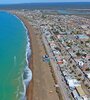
(42, 34, 74, 100)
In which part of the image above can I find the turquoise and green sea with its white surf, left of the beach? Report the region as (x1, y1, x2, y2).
(0, 12, 32, 100)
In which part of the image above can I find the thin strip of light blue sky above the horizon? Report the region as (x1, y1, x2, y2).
(0, 0, 90, 4)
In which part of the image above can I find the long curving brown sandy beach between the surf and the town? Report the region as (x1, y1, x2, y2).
(14, 15, 59, 100)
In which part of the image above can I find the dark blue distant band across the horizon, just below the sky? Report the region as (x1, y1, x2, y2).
(0, 2, 90, 10)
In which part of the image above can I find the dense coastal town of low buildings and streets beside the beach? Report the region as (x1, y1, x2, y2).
(10, 9, 90, 100)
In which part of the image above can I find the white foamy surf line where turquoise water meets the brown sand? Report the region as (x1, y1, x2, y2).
(14, 15, 32, 100)
